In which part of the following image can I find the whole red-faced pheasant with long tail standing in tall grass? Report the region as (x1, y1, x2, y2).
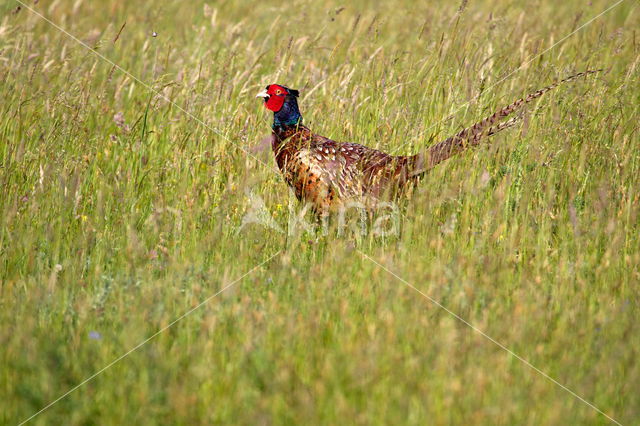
(256, 70, 600, 218)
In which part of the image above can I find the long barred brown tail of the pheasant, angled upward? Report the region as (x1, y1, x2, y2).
(411, 70, 602, 176)
